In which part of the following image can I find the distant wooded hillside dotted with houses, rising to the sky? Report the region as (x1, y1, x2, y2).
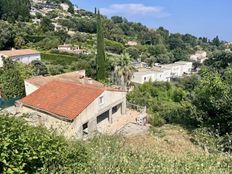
(0, 0, 227, 78)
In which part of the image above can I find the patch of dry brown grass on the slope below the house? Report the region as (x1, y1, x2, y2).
(125, 125, 205, 156)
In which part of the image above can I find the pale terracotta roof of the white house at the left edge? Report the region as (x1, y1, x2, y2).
(0, 49, 39, 57)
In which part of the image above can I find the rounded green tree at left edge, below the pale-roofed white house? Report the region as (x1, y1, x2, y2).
(0, 58, 25, 99)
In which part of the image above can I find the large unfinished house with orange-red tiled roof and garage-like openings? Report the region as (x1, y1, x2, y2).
(19, 72, 126, 138)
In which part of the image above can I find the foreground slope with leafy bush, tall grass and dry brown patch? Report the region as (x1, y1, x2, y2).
(0, 116, 232, 174)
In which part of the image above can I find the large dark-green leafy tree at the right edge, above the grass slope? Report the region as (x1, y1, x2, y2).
(193, 69, 232, 134)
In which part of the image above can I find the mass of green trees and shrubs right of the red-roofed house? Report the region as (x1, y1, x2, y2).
(127, 56, 232, 153)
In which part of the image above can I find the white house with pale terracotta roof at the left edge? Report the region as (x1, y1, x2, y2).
(0, 49, 41, 67)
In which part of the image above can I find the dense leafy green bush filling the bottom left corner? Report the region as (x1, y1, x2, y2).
(0, 115, 87, 173)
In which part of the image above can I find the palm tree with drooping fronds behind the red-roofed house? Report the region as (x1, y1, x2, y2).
(115, 53, 135, 88)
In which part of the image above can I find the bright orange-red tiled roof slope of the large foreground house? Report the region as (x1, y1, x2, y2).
(21, 81, 104, 120)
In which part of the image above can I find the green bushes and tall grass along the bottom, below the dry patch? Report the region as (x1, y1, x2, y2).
(0, 115, 232, 174)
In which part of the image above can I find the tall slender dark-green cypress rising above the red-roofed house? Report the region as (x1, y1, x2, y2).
(96, 11, 106, 81)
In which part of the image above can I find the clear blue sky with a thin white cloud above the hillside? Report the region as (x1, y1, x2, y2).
(72, 0, 232, 41)
